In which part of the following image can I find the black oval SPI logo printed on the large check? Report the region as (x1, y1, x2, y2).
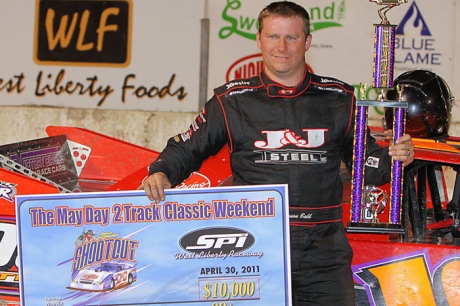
(179, 227, 255, 253)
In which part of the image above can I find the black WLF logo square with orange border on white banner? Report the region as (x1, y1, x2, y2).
(34, 0, 132, 67)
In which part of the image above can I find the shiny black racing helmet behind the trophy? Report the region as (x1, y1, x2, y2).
(385, 70, 454, 139)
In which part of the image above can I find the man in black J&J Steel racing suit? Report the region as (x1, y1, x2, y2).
(143, 1, 413, 306)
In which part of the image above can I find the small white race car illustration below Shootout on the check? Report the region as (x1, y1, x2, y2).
(69, 261, 137, 291)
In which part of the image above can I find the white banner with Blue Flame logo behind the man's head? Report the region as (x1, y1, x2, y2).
(208, 0, 459, 118)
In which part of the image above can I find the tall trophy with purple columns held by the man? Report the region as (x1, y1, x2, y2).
(347, 0, 408, 233)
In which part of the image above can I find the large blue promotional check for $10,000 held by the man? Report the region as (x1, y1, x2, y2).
(16, 185, 291, 306)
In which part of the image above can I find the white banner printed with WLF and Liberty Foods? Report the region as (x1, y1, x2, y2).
(0, 0, 204, 112)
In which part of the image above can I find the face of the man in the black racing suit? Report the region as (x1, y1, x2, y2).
(257, 17, 311, 86)
